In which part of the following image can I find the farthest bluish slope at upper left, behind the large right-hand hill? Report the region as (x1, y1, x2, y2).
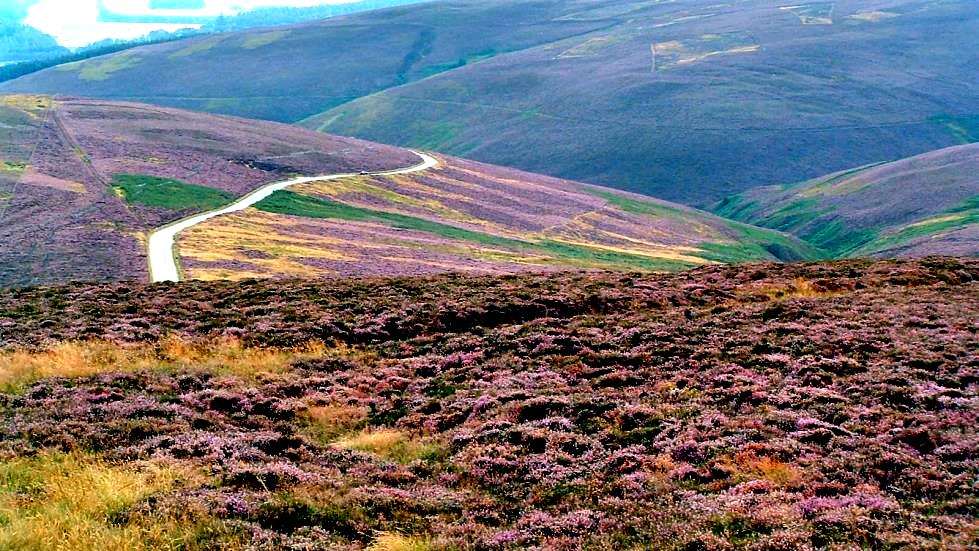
(0, 0, 607, 122)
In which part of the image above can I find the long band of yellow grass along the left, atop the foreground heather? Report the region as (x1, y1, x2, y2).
(0, 337, 325, 392)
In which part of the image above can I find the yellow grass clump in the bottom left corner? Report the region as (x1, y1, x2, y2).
(0, 453, 213, 551)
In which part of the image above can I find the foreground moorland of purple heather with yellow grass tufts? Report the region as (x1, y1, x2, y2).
(0, 259, 979, 551)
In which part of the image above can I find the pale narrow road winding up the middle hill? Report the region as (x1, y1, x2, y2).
(147, 151, 438, 283)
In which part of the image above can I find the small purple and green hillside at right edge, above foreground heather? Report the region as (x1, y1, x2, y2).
(712, 144, 979, 257)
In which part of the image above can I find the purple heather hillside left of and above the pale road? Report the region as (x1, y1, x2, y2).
(0, 96, 416, 286)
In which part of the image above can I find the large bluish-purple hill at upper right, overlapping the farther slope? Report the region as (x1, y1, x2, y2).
(303, 0, 979, 206)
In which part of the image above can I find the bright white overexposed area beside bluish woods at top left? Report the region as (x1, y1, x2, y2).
(23, 0, 357, 48)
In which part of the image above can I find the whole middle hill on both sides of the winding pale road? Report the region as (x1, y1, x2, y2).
(0, 96, 816, 286)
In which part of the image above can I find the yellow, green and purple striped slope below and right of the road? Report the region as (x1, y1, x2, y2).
(179, 152, 820, 279)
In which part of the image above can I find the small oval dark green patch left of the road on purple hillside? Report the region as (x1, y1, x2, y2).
(112, 174, 234, 211)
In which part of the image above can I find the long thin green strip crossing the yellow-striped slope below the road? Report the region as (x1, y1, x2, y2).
(255, 191, 693, 271)
